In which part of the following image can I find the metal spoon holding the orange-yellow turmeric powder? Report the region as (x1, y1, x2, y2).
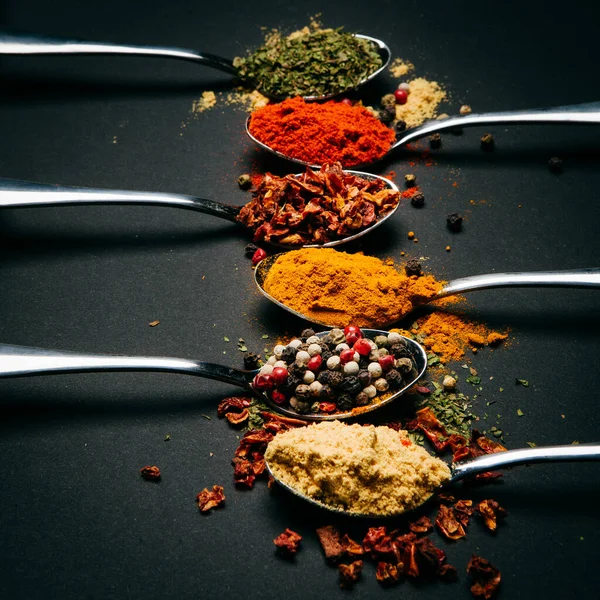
(254, 254, 600, 327)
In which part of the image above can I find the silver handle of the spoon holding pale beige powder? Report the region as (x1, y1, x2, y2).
(451, 444, 600, 482)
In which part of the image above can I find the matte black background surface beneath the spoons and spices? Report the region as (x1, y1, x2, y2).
(0, 0, 600, 599)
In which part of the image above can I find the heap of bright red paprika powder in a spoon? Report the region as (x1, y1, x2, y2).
(249, 97, 395, 167)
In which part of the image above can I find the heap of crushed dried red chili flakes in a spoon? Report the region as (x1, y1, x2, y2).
(237, 163, 400, 246)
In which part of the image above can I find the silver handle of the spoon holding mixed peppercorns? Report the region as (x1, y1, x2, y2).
(0, 344, 255, 388)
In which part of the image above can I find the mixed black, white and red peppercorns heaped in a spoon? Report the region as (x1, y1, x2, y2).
(252, 325, 418, 414)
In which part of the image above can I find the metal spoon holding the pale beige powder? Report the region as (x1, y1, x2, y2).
(267, 444, 600, 518)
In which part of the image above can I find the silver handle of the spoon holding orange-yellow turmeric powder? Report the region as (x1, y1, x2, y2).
(436, 268, 600, 298)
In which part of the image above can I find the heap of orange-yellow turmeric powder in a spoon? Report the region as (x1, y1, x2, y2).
(264, 248, 443, 327)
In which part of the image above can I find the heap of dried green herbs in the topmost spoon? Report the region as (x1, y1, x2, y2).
(233, 29, 382, 98)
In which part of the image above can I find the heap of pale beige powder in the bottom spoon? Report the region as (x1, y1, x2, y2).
(265, 421, 450, 516)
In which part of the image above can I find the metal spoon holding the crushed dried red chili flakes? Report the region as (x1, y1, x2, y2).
(0, 170, 400, 249)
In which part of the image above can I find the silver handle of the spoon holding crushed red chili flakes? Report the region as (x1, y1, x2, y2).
(0, 179, 240, 222)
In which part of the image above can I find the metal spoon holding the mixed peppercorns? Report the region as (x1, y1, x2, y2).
(0, 329, 427, 421)
